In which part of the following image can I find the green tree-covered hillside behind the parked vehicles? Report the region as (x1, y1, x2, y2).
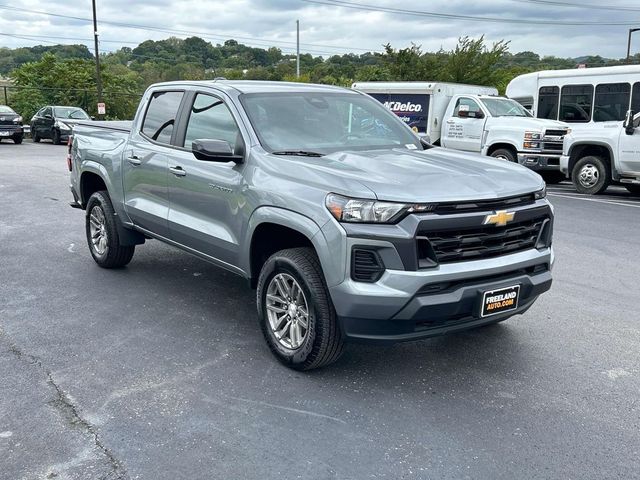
(0, 37, 640, 118)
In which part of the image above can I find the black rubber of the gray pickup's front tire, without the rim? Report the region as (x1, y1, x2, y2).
(257, 248, 344, 370)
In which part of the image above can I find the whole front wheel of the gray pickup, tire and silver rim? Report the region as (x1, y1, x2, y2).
(257, 248, 344, 370)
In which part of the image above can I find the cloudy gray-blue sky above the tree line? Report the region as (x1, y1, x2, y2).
(0, 0, 640, 58)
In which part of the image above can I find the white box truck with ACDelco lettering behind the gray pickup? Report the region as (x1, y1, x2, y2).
(352, 82, 569, 183)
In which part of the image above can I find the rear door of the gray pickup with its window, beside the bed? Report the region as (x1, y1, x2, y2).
(122, 90, 185, 238)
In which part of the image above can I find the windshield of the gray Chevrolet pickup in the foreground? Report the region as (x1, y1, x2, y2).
(240, 92, 422, 154)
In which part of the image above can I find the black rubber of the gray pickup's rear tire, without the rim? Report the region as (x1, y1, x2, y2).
(85, 191, 136, 268)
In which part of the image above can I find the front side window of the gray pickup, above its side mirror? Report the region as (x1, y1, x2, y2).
(184, 93, 240, 149)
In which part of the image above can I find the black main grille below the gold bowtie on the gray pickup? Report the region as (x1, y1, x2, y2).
(424, 217, 546, 263)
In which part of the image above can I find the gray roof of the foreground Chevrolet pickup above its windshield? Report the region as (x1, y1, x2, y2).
(152, 79, 355, 93)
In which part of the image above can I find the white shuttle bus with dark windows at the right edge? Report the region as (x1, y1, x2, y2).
(507, 65, 640, 194)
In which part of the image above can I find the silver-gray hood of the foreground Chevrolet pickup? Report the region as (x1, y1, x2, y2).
(262, 148, 544, 203)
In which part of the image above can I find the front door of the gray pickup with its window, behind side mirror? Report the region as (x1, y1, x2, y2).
(168, 91, 246, 265)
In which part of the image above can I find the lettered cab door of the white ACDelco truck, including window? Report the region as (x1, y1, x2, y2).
(442, 97, 487, 152)
